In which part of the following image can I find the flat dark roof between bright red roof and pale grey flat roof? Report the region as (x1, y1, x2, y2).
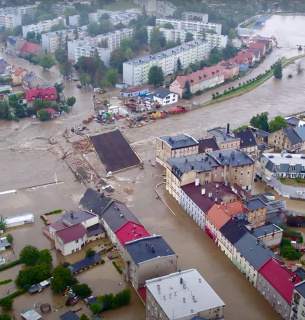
(125, 236, 175, 264)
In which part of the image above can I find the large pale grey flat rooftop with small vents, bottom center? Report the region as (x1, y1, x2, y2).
(146, 269, 225, 319)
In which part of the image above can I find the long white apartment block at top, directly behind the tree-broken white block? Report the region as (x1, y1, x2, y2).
(156, 18, 222, 34)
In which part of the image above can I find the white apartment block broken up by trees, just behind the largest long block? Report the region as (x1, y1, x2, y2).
(147, 26, 228, 51)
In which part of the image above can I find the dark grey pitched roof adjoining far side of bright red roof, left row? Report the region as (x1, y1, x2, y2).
(102, 201, 140, 232)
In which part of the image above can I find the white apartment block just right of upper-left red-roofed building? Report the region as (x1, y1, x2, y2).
(41, 26, 88, 53)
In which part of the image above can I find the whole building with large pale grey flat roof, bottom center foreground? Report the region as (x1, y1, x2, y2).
(145, 269, 225, 320)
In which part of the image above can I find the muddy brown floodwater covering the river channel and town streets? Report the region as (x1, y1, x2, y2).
(0, 17, 305, 320)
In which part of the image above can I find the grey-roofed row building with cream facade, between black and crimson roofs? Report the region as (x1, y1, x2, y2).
(232, 232, 274, 287)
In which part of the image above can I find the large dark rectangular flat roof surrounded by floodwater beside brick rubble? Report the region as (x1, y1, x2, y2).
(90, 130, 141, 172)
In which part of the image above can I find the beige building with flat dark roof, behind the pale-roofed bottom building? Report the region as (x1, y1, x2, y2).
(125, 235, 178, 289)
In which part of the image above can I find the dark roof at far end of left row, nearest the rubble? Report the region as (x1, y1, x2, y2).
(79, 188, 112, 215)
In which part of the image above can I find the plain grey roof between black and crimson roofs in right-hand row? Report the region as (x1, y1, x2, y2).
(234, 233, 273, 270)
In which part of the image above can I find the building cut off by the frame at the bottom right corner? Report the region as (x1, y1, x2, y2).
(290, 281, 305, 320)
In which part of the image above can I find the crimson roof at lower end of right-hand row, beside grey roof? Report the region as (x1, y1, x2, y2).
(258, 258, 302, 304)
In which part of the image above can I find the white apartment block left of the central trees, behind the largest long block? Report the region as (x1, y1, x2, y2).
(68, 28, 133, 61)
